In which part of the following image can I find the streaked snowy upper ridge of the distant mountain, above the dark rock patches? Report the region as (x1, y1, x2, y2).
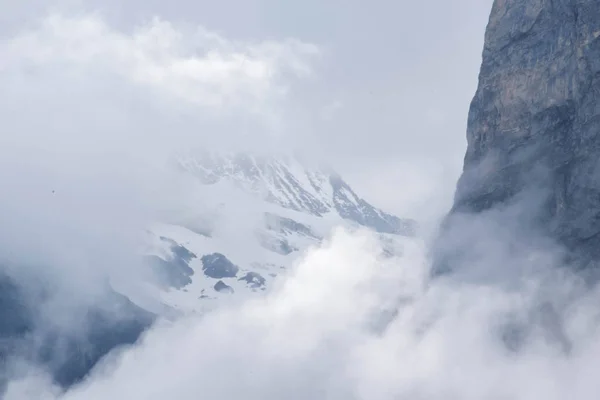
(179, 151, 416, 235)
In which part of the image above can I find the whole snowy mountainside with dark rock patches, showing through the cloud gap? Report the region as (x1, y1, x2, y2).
(137, 152, 416, 312)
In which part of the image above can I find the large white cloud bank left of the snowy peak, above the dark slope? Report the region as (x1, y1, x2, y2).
(0, 14, 318, 324)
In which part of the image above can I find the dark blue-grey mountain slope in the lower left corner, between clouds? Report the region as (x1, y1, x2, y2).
(0, 272, 155, 390)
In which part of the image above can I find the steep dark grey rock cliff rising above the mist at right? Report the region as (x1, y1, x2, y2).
(452, 0, 600, 261)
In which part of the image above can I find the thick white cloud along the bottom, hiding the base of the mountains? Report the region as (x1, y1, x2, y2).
(6, 230, 600, 400)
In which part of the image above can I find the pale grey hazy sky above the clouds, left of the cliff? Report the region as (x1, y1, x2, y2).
(0, 0, 491, 219)
